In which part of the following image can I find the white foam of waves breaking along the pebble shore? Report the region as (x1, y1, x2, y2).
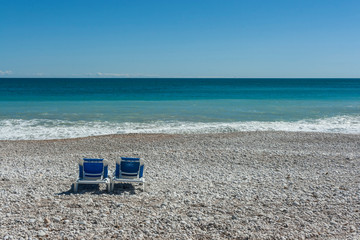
(0, 116, 360, 140)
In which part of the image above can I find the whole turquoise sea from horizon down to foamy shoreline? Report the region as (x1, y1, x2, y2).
(0, 78, 360, 140)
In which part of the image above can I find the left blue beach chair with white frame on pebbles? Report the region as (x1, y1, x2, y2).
(74, 158, 111, 192)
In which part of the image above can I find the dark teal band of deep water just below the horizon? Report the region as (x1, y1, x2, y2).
(0, 78, 360, 101)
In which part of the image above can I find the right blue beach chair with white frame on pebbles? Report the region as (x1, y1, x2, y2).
(111, 157, 145, 191)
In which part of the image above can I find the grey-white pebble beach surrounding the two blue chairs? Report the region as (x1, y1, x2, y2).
(0, 132, 360, 239)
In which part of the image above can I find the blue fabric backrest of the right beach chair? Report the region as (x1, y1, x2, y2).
(115, 157, 144, 178)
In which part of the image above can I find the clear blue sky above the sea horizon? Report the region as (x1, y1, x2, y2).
(0, 0, 360, 77)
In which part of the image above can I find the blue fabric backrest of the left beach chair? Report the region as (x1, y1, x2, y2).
(79, 158, 108, 179)
